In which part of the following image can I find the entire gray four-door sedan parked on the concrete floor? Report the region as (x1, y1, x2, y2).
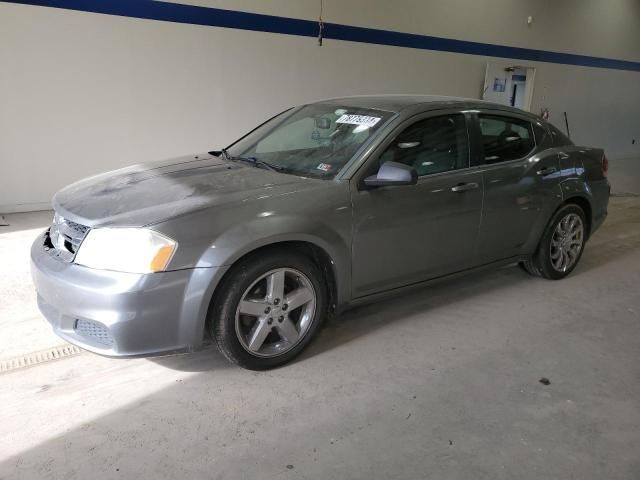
(31, 96, 610, 370)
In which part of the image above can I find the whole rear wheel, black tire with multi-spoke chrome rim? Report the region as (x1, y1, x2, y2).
(521, 204, 587, 280)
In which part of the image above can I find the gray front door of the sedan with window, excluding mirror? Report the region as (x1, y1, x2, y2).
(352, 113, 483, 298)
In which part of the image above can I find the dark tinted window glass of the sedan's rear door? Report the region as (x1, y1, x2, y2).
(479, 115, 535, 164)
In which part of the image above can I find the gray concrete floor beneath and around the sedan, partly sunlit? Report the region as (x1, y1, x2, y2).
(0, 196, 640, 480)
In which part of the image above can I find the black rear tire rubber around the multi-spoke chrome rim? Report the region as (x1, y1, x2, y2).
(521, 203, 588, 280)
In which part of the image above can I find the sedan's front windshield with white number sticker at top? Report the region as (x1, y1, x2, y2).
(227, 104, 394, 179)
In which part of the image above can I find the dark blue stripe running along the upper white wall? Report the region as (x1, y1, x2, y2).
(5, 0, 640, 72)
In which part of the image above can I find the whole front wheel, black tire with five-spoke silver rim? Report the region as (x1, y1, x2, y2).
(208, 250, 327, 370)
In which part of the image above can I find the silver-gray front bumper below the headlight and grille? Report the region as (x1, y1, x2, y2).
(31, 231, 216, 356)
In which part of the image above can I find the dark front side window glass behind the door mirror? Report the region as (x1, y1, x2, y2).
(380, 114, 469, 176)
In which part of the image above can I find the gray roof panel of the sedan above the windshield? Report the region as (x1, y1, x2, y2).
(315, 94, 535, 116)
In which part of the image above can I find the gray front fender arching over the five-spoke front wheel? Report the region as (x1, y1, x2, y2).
(153, 181, 351, 347)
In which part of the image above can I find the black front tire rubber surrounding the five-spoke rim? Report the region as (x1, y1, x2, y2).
(207, 248, 328, 370)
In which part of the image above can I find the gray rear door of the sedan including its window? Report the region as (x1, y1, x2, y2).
(471, 110, 560, 264)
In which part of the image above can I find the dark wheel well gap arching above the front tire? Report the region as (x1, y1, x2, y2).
(205, 241, 338, 330)
